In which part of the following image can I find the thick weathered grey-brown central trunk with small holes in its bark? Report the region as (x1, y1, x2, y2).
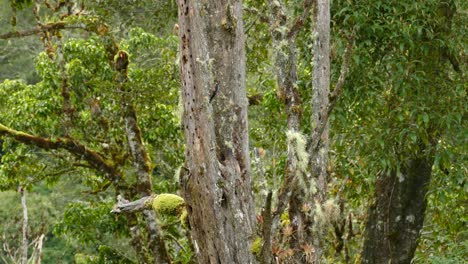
(178, 0, 255, 264)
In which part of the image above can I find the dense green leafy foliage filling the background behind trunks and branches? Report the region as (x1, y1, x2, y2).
(0, 0, 468, 263)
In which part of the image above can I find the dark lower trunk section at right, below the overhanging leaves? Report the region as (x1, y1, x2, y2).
(361, 158, 433, 264)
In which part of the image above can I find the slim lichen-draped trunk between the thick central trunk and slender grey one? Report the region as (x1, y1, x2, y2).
(262, 0, 312, 263)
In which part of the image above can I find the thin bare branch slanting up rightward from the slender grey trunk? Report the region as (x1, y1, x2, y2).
(309, 32, 354, 152)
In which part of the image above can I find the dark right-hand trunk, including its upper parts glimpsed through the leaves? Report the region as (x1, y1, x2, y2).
(361, 1, 457, 264)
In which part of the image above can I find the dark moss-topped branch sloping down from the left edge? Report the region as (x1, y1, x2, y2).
(0, 124, 121, 182)
